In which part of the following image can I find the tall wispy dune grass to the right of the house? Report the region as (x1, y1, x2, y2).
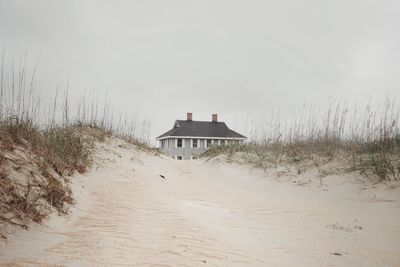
(202, 101, 400, 186)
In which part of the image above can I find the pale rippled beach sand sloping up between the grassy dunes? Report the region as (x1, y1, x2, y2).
(0, 139, 400, 266)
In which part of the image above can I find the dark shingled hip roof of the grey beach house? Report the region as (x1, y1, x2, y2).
(156, 120, 246, 139)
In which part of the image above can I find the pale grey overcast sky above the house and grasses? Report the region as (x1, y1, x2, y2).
(0, 0, 400, 141)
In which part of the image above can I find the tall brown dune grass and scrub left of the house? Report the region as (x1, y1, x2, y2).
(0, 55, 150, 238)
